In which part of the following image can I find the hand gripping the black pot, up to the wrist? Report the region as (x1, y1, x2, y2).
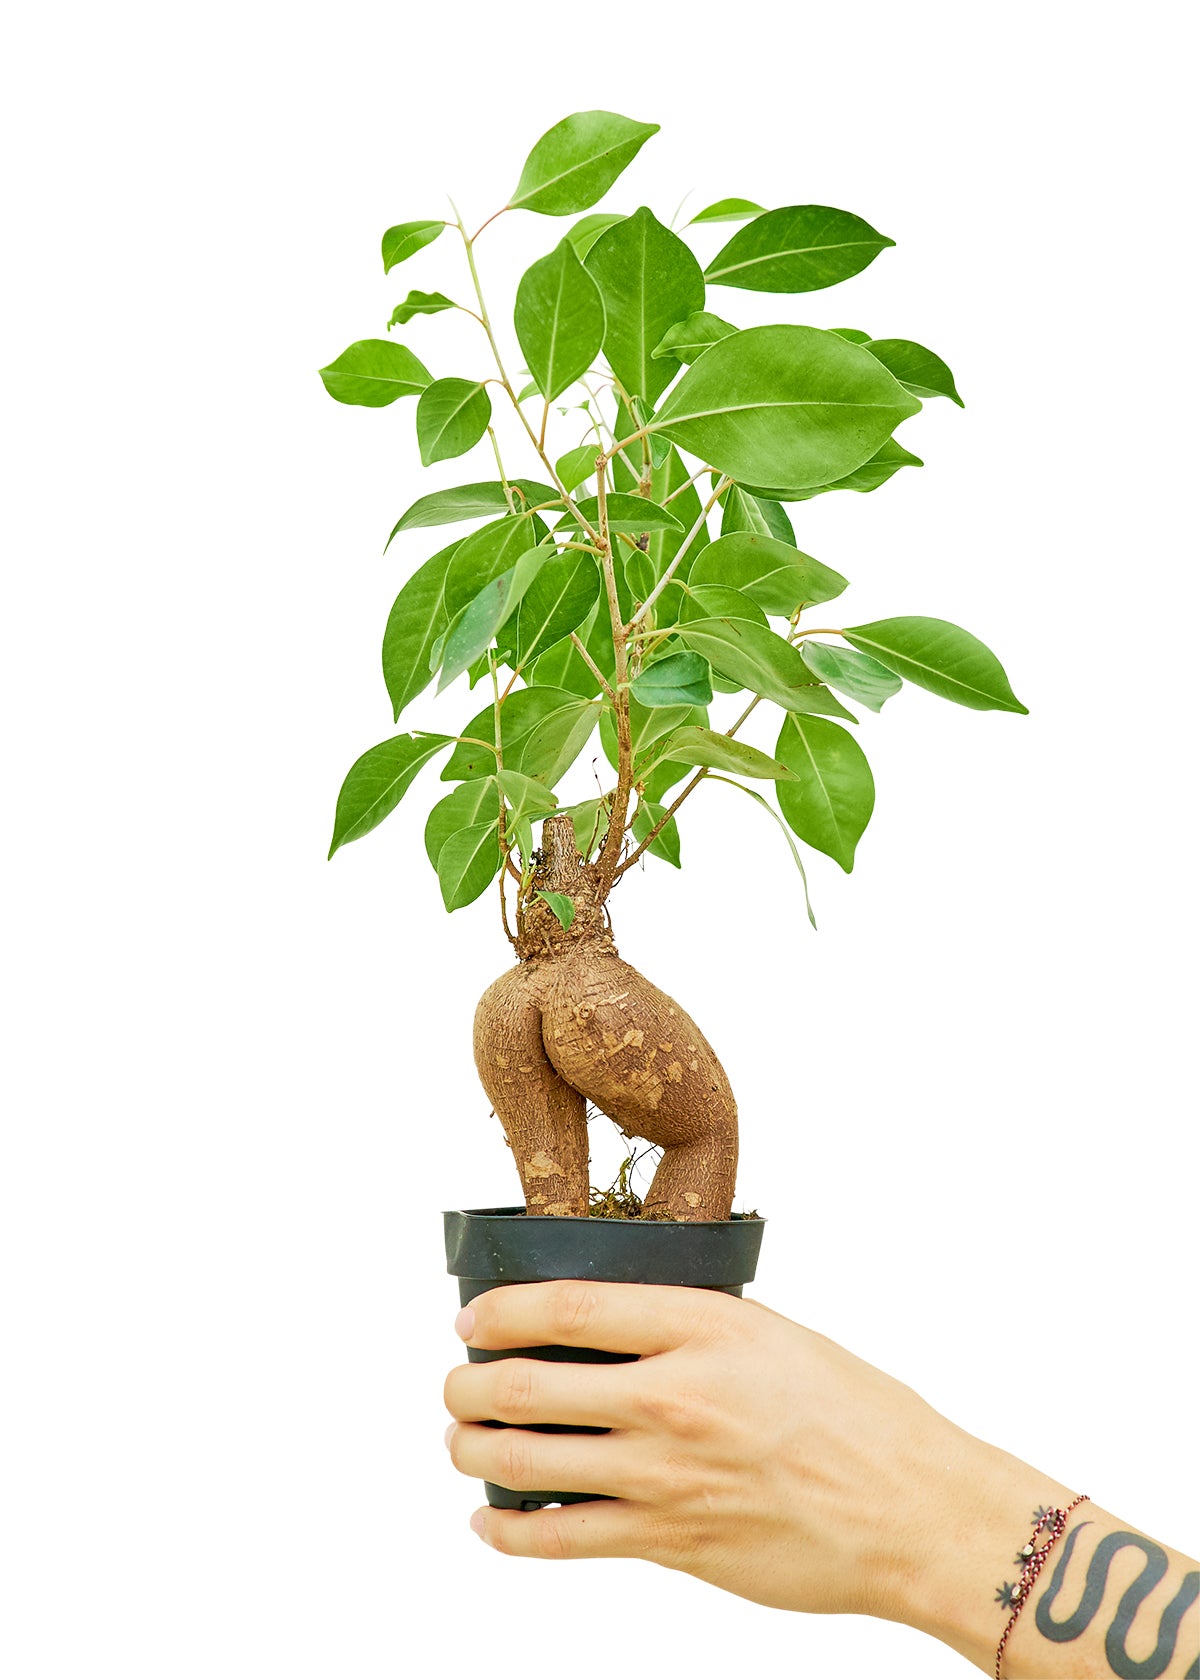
(445, 1282, 1028, 1621)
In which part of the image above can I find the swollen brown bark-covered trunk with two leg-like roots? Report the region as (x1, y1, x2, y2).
(476, 816, 738, 1220)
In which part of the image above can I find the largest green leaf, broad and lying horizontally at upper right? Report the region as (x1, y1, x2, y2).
(652, 324, 921, 489)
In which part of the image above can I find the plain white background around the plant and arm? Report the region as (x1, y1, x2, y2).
(0, 0, 1200, 1680)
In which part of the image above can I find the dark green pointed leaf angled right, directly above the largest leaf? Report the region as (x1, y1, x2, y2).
(704, 205, 896, 292)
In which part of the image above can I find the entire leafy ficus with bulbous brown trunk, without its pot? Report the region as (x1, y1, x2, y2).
(321, 111, 1025, 1220)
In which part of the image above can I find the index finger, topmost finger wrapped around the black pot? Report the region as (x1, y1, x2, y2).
(455, 1278, 741, 1356)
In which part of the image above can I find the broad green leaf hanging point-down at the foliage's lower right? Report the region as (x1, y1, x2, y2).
(775, 714, 876, 875)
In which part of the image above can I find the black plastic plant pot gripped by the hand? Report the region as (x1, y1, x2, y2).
(444, 1208, 765, 1510)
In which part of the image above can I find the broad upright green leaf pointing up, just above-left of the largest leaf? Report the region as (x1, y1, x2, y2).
(587, 208, 705, 404)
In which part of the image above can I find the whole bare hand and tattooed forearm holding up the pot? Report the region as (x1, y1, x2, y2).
(445, 1282, 1200, 1680)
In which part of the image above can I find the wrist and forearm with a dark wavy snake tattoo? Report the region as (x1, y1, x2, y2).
(891, 1430, 1200, 1680)
